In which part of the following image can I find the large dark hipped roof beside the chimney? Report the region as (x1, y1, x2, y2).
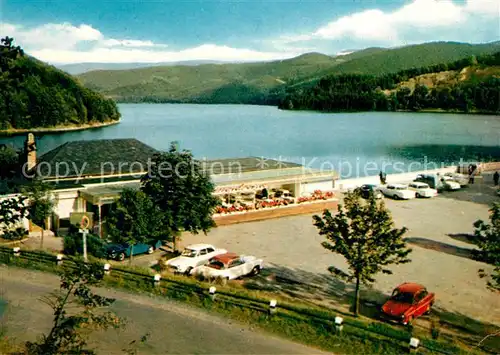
(37, 139, 158, 179)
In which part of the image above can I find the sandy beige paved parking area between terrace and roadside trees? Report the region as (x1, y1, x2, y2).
(183, 185, 500, 324)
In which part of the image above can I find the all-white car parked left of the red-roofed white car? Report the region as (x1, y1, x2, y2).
(165, 244, 227, 275)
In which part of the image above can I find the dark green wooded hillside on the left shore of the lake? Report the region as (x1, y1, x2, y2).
(0, 37, 120, 132)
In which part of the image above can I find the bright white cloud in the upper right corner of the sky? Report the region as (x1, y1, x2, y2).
(280, 0, 500, 44)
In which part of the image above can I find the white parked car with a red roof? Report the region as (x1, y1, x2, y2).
(193, 253, 263, 281)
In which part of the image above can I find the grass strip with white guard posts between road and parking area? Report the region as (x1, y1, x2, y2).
(0, 250, 488, 354)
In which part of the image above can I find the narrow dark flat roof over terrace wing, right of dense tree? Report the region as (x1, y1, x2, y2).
(202, 157, 302, 174)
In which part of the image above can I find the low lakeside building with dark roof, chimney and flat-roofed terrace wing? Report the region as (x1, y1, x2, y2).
(14, 135, 337, 236)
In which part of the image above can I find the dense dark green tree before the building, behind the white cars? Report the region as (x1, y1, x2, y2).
(142, 143, 219, 250)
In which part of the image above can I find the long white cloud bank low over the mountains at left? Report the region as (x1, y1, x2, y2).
(0, 23, 300, 64)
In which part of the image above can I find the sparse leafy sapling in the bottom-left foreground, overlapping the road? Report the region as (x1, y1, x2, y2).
(26, 263, 123, 355)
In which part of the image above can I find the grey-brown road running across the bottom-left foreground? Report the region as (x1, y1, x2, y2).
(0, 266, 328, 354)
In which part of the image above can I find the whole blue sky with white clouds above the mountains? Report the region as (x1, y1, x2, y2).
(0, 0, 500, 64)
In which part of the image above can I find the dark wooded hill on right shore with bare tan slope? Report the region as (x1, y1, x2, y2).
(279, 51, 500, 113)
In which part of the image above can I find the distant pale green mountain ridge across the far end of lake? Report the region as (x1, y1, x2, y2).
(78, 42, 500, 105)
